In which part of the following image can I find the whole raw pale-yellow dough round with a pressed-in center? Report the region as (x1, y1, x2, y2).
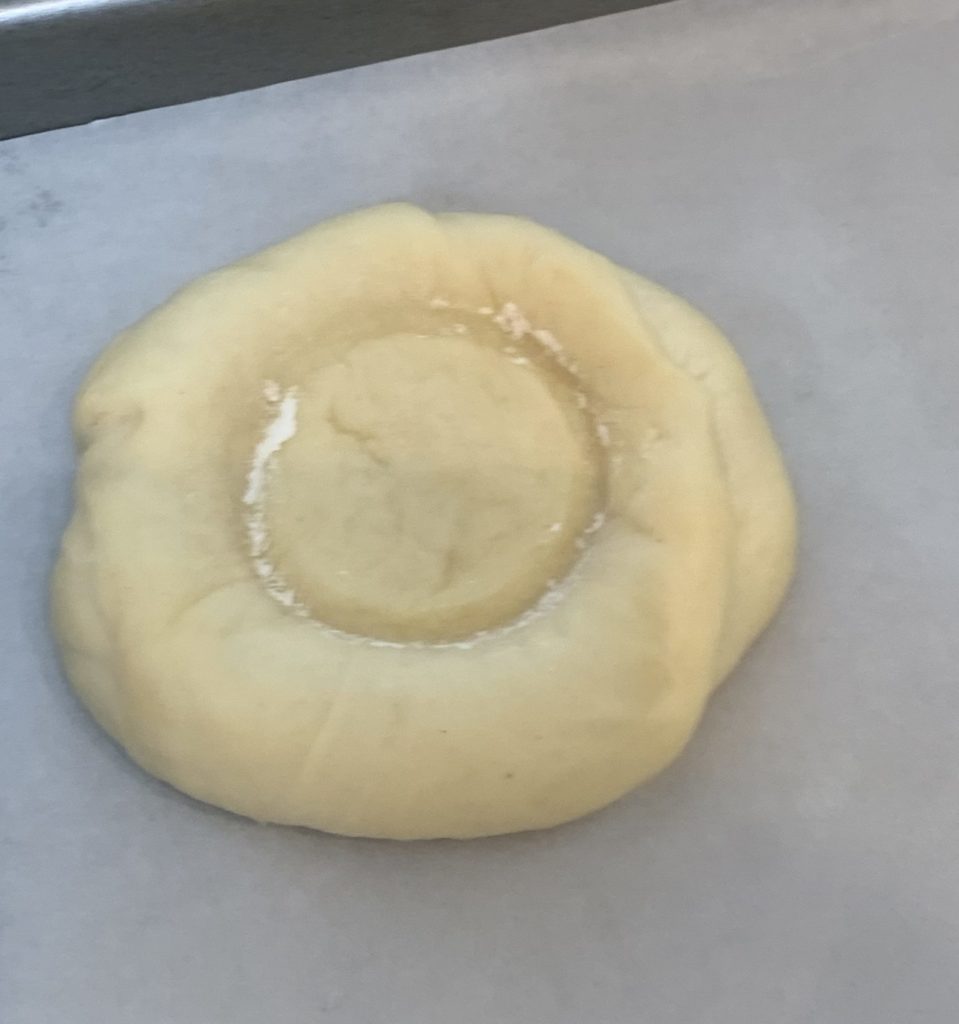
(53, 205, 795, 839)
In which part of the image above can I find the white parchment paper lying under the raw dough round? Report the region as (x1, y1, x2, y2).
(0, 0, 959, 1024)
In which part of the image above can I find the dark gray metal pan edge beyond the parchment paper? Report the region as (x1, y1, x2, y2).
(0, 0, 663, 138)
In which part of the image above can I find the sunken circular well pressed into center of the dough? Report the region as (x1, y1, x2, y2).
(254, 334, 602, 642)
